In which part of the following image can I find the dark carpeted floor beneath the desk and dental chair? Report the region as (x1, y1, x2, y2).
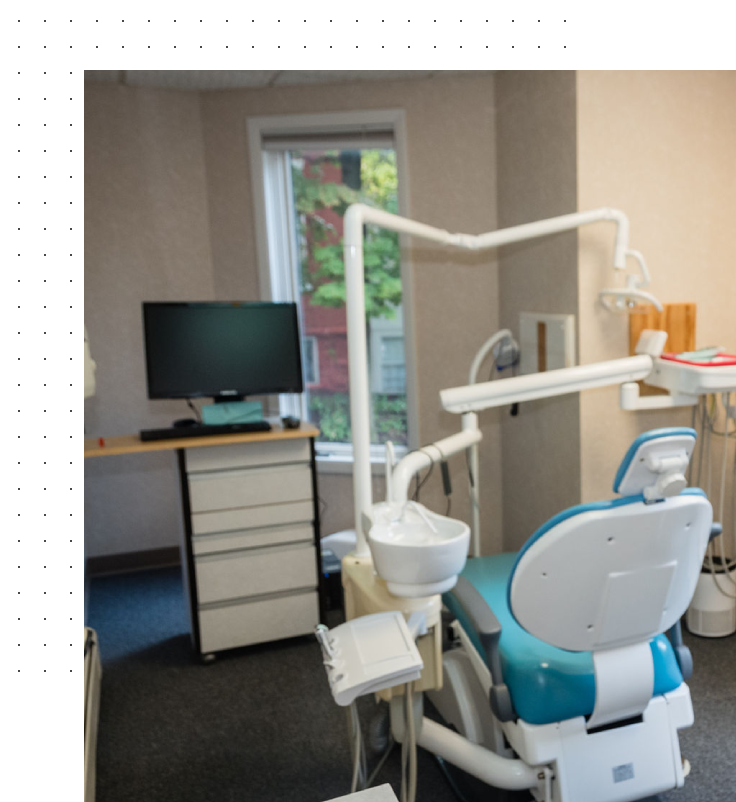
(89, 569, 736, 802)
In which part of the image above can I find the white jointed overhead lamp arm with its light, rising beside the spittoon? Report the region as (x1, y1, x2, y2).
(343, 203, 660, 556)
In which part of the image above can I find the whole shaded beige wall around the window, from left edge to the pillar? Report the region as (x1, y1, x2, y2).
(85, 75, 501, 556)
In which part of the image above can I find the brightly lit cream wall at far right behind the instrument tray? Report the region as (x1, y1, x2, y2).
(577, 72, 736, 536)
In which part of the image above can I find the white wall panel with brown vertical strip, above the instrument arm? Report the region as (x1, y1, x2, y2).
(519, 312, 576, 373)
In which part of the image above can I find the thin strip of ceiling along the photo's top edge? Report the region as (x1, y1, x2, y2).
(84, 70, 490, 90)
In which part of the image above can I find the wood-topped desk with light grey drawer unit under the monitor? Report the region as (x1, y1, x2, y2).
(84, 424, 324, 658)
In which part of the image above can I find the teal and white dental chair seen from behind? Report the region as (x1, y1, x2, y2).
(436, 428, 712, 802)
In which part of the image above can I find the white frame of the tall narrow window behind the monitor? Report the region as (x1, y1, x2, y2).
(246, 109, 419, 473)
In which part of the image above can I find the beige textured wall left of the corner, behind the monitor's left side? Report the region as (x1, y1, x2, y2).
(84, 84, 213, 557)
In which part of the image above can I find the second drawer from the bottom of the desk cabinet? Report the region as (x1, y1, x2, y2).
(194, 543, 317, 604)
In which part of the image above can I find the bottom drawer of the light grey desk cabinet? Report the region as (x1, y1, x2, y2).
(199, 591, 319, 654)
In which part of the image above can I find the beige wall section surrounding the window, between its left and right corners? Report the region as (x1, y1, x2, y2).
(202, 75, 501, 551)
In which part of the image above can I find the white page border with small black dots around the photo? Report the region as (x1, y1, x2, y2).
(7, 0, 735, 800)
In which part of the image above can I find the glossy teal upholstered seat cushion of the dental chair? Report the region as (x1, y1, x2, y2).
(443, 553, 682, 724)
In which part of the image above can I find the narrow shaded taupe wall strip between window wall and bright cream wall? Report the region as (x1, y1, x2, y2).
(494, 71, 580, 549)
